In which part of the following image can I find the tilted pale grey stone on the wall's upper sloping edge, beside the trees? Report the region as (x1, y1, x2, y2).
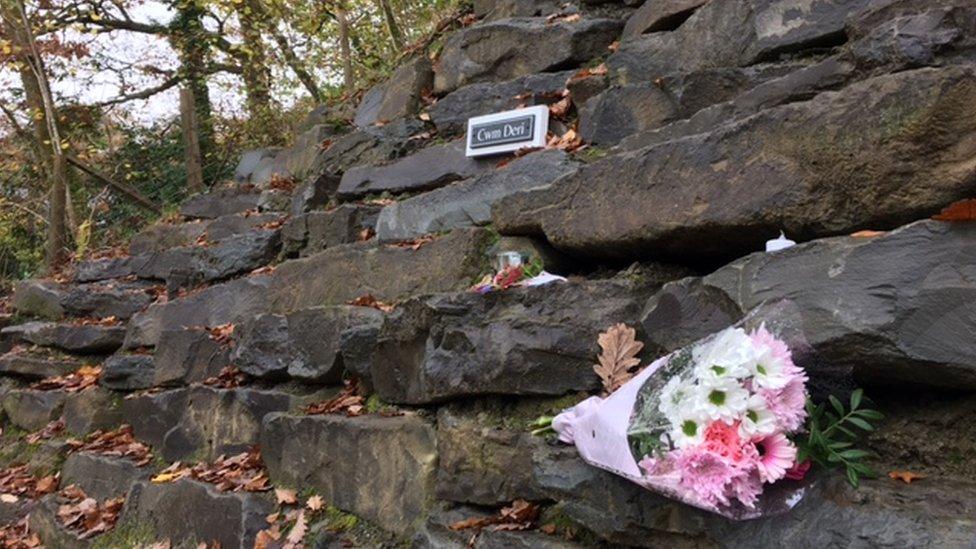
(354, 55, 434, 126)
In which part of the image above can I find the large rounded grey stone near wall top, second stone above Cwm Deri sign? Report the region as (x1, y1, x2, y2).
(434, 17, 621, 95)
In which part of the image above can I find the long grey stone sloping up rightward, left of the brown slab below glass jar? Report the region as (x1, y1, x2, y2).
(125, 276, 270, 349)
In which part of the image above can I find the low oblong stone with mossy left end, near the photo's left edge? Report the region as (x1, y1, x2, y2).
(11, 280, 159, 320)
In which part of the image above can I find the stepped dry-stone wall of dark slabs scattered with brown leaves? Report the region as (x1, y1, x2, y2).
(0, 0, 976, 548)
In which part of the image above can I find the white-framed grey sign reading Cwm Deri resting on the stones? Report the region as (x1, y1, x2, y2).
(467, 105, 549, 156)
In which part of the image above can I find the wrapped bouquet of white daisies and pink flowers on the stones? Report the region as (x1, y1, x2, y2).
(552, 308, 810, 519)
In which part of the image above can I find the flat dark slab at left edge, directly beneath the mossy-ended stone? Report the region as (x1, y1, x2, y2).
(0, 321, 125, 354)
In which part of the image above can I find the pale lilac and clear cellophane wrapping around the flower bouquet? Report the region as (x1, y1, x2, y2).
(553, 301, 816, 520)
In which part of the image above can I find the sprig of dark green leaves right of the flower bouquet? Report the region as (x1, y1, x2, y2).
(794, 389, 884, 488)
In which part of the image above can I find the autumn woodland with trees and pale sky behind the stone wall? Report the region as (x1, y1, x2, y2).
(0, 0, 465, 285)
